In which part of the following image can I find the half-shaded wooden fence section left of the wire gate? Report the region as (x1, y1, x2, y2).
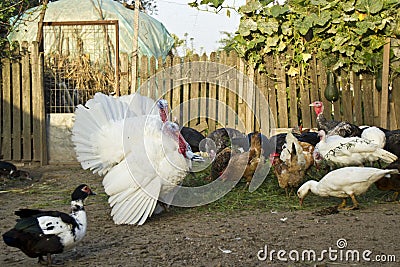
(0, 42, 47, 164)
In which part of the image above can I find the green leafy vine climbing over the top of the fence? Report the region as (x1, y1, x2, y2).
(190, 0, 400, 76)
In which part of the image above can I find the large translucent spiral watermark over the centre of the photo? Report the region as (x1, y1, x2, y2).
(124, 62, 275, 207)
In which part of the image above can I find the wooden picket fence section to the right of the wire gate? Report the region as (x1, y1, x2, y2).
(120, 52, 400, 132)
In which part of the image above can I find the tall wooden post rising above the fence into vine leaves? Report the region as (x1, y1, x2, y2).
(380, 37, 390, 128)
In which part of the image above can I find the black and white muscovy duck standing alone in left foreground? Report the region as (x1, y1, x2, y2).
(3, 184, 95, 265)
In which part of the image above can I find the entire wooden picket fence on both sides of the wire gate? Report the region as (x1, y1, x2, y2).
(0, 43, 400, 164)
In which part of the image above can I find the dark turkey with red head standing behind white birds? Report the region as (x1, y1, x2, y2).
(310, 101, 362, 137)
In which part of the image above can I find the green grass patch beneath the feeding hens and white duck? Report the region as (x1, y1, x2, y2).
(176, 167, 392, 216)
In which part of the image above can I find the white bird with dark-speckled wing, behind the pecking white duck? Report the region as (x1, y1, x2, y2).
(314, 130, 397, 166)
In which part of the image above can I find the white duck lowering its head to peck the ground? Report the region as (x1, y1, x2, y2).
(297, 167, 399, 210)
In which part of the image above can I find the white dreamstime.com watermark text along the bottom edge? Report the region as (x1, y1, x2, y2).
(257, 238, 396, 263)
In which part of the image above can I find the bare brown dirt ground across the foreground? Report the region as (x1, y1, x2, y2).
(0, 166, 400, 266)
